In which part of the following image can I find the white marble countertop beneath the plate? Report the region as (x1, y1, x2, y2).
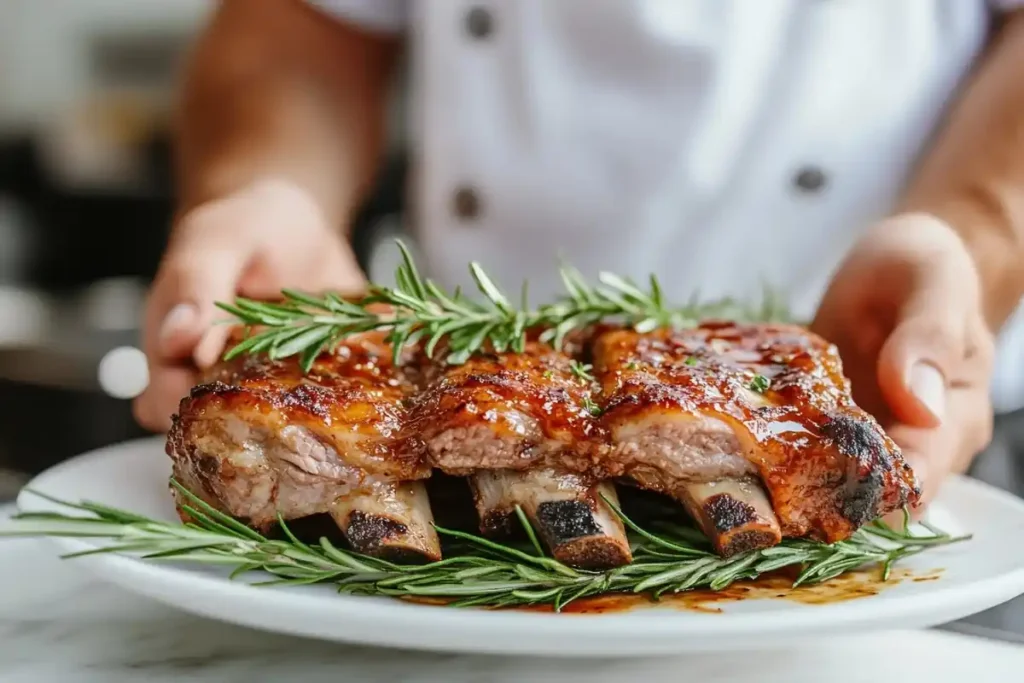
(0, 505, 1024, 683)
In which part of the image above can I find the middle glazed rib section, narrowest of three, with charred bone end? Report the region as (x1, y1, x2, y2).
(410, 341, 631, 569)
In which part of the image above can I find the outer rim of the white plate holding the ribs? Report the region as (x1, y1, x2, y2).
(12, 439, 1024, 656)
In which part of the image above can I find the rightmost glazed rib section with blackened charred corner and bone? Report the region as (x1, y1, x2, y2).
(593, 324, 920, 555)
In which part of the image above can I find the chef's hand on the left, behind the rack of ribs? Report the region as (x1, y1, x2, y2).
(134, 180, 365, 430)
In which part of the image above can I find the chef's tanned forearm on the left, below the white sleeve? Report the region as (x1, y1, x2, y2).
(175, 0, 397, 231)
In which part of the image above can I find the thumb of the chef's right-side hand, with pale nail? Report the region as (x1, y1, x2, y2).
(878, 293, 966, 427)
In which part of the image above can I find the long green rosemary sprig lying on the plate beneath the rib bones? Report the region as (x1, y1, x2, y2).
(0, 486, 969, 611)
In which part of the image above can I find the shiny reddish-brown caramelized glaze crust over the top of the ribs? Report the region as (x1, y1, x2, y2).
(174, 323, 920, 542)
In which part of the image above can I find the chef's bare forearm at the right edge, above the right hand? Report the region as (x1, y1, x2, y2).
(903, 12, 1024, 330)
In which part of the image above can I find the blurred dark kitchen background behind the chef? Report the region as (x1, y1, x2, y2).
(0, 0, 1024, 634)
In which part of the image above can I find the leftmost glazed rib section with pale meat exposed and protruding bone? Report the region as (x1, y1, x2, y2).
(167, 334, 440, 561)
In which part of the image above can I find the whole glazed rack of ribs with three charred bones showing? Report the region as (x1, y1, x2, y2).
(167, 323, 920, 569)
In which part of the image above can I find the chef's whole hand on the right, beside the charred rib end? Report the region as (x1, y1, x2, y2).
(811, 214, 994, 505)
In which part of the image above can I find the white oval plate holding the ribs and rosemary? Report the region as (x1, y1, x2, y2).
(12, 440, 1024, 656)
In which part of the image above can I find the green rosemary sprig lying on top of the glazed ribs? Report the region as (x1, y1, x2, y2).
(218, 242, 787, 370)
